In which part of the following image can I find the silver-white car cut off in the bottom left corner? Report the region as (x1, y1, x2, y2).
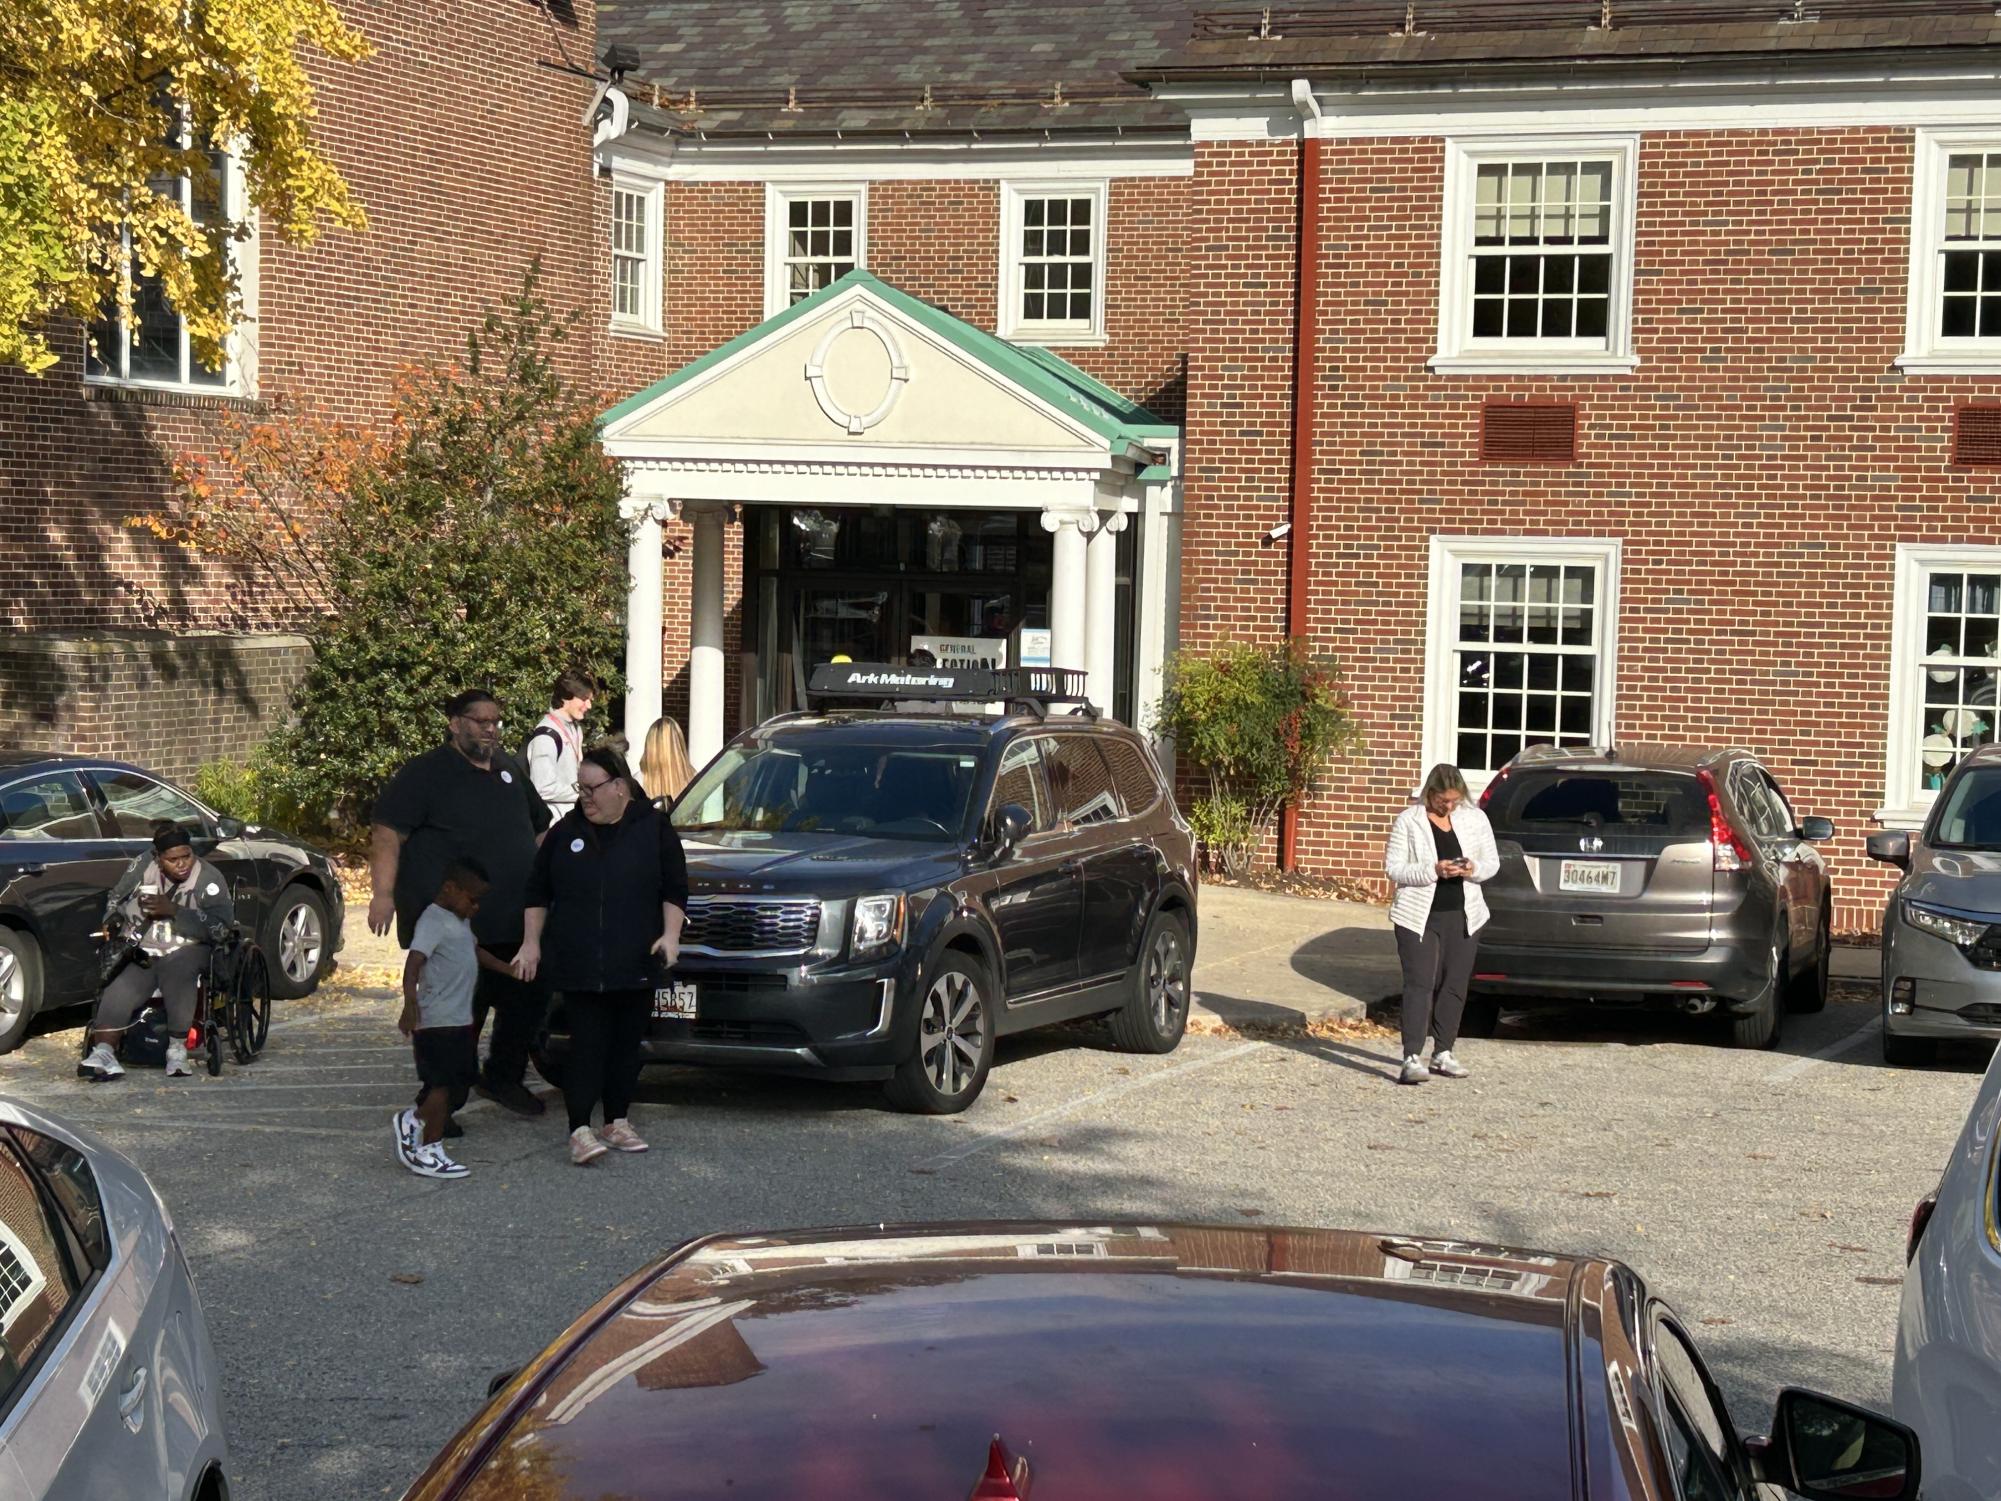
(0, 1101, 230, 1501)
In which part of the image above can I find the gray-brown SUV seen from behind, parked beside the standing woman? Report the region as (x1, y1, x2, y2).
(1469, 744, 1835, 1047)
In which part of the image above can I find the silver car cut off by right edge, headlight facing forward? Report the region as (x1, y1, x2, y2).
(1869, 744, 2001, 1063)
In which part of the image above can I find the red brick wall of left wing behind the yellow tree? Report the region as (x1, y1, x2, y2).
(0, 0, 600, 755)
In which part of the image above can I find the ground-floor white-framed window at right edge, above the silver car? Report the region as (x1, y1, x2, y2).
(1877, 542, 2001, 827)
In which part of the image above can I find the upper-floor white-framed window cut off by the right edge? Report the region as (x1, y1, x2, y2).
(1897, 130, 2001, 374)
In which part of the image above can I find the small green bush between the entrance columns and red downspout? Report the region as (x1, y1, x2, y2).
(1155, 640, 1361, 879)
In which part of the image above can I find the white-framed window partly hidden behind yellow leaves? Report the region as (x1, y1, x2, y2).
(84, 150, 256, 394)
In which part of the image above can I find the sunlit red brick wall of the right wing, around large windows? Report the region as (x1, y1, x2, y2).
(1183, 130, 2001, 923)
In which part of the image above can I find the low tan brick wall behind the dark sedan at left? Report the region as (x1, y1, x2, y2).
(0, 632, 312, 779)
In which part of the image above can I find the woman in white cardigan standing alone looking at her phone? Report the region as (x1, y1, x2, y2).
(1383, 763, 1501, 1085)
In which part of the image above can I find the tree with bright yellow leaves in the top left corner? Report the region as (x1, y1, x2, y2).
(0, 0, 368, 372)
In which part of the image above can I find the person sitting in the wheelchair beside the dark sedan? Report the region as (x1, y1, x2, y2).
(76, 823, 236, 1081)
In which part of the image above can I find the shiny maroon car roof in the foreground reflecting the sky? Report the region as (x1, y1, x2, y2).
(410, 1225, 1607, 1501)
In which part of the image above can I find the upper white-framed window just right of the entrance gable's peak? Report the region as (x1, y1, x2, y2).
(998, 182, 1109, 344)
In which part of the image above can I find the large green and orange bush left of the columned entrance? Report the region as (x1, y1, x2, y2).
(160, 272, 628, 843)
